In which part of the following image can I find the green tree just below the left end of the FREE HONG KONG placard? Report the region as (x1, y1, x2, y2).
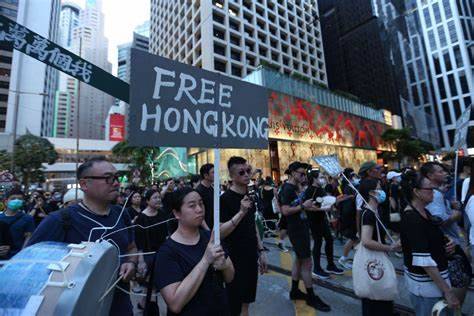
(112, 141, 160, 185)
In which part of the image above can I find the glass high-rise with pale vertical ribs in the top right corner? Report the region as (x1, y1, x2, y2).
(378, 0, 474, 149)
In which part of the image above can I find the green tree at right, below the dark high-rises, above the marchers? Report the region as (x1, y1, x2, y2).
(382, 128, 434, 164)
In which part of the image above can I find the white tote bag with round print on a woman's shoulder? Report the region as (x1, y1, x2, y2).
(352, 212, 398, 301)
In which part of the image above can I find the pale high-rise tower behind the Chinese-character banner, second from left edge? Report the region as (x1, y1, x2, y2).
(5, 0, 60, 136)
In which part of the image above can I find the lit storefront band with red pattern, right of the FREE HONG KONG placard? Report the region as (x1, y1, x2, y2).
(268, 92, 389, 149)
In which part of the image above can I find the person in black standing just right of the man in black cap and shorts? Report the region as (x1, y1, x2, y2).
(305, 170, 344, 279)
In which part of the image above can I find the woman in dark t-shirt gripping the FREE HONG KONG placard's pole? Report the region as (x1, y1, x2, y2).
(154, 188, 234, 316)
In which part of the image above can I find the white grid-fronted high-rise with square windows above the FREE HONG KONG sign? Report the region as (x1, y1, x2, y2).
(150, 0, 327, 85)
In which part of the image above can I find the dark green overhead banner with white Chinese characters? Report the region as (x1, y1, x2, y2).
(0, 15, 130, 103)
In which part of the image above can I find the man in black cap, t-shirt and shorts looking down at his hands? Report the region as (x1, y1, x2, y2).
(278, 161, 331, 312)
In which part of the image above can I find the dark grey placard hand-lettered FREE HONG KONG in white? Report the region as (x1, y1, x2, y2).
(129, 49, 268, 148)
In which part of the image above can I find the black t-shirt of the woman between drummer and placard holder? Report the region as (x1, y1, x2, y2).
(135, 210, 168, 252)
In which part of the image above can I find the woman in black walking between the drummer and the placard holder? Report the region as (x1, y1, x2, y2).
(135, 190, 168, 308)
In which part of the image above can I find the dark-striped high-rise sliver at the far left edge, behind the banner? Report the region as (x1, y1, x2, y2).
(0, 0, 18, 133)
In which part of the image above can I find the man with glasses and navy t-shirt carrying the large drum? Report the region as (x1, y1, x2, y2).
(29, 157, 137, 315)
